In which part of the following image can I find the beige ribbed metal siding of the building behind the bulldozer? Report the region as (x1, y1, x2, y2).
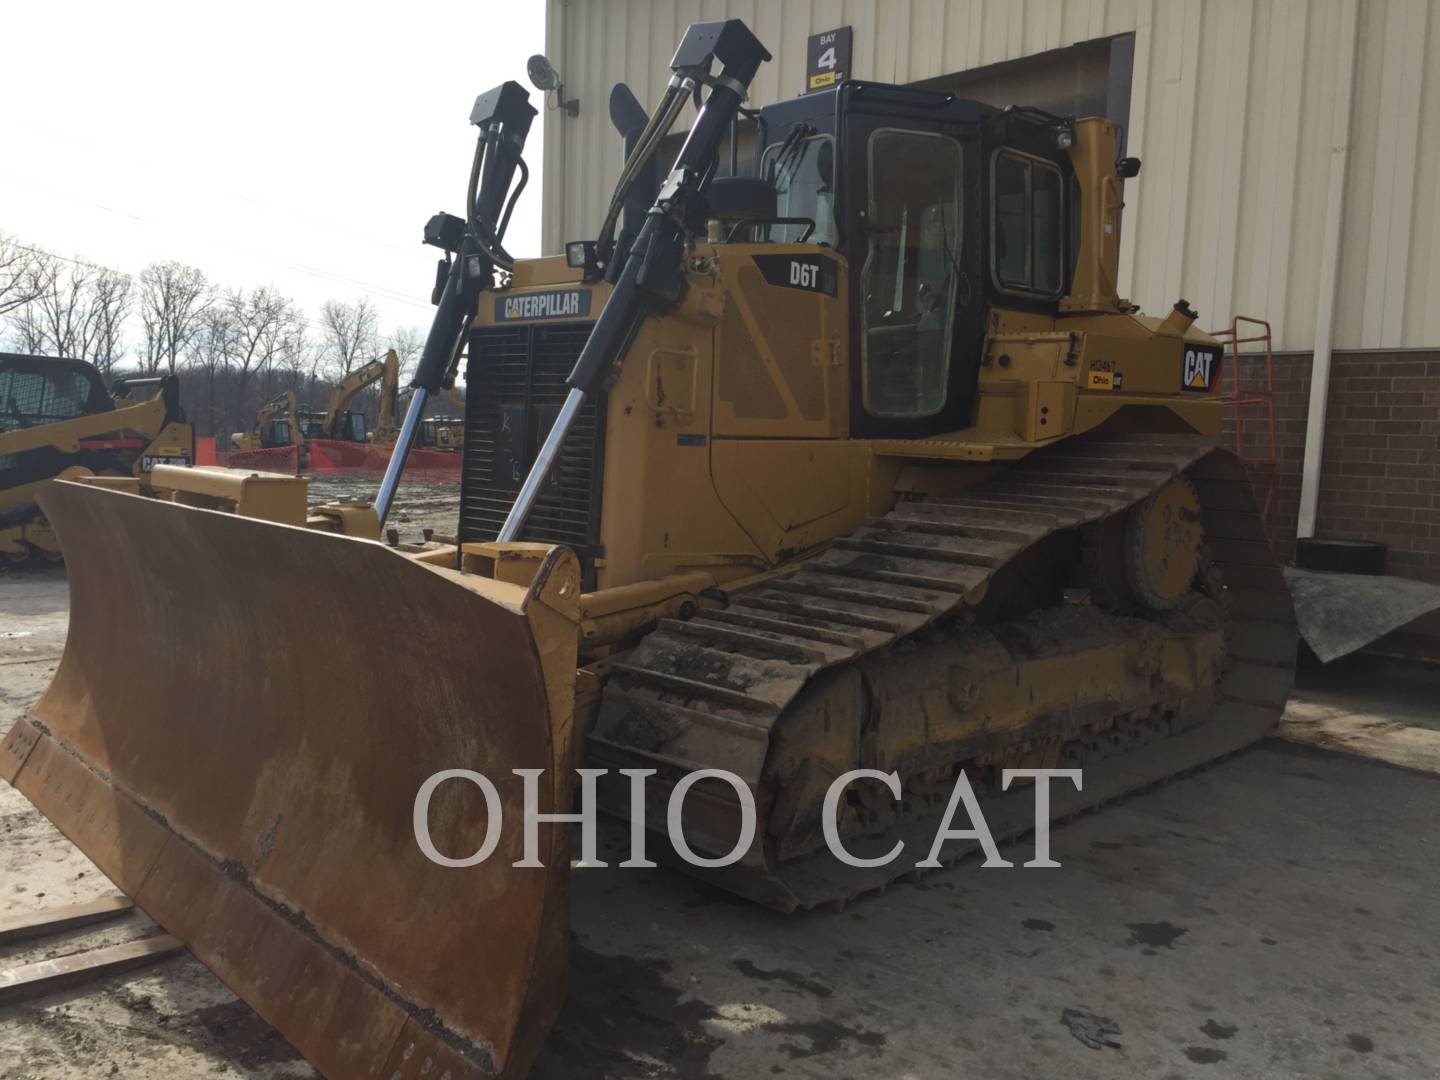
(544, 0, 1440, 350)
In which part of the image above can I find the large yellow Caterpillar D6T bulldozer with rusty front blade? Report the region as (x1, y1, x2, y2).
(0, 20, 1296, 1079)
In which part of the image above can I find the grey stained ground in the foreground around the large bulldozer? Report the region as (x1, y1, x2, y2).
(0, 570, 1440, 1080)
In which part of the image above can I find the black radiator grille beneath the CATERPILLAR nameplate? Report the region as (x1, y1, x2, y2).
(459, 323, 605, 589)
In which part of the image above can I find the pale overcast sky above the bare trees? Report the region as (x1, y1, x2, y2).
(0, 0, 544, 338)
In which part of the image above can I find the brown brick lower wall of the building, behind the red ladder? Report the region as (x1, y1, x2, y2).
(1244, 350, 1440, 582)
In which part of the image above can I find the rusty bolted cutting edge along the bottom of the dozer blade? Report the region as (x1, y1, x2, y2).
(3, 716, 501, 1080)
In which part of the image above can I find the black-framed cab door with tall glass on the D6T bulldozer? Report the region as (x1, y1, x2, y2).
(842, 84, 985, 438)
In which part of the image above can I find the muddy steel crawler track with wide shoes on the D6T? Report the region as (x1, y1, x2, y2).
(589, 433, 1295, 910)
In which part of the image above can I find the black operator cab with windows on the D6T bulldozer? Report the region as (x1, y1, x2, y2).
(748, 81, 1079, 438)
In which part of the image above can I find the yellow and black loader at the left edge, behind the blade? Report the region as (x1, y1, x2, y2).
(0, 353, 194, 563)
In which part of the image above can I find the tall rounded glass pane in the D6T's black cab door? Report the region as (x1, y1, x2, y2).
(861, 128, 960, 418)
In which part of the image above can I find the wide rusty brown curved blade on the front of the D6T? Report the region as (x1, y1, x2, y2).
(0, 482, 579, 1080)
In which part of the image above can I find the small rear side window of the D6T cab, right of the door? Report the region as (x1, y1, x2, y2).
(991, 150, 1064, 297)
